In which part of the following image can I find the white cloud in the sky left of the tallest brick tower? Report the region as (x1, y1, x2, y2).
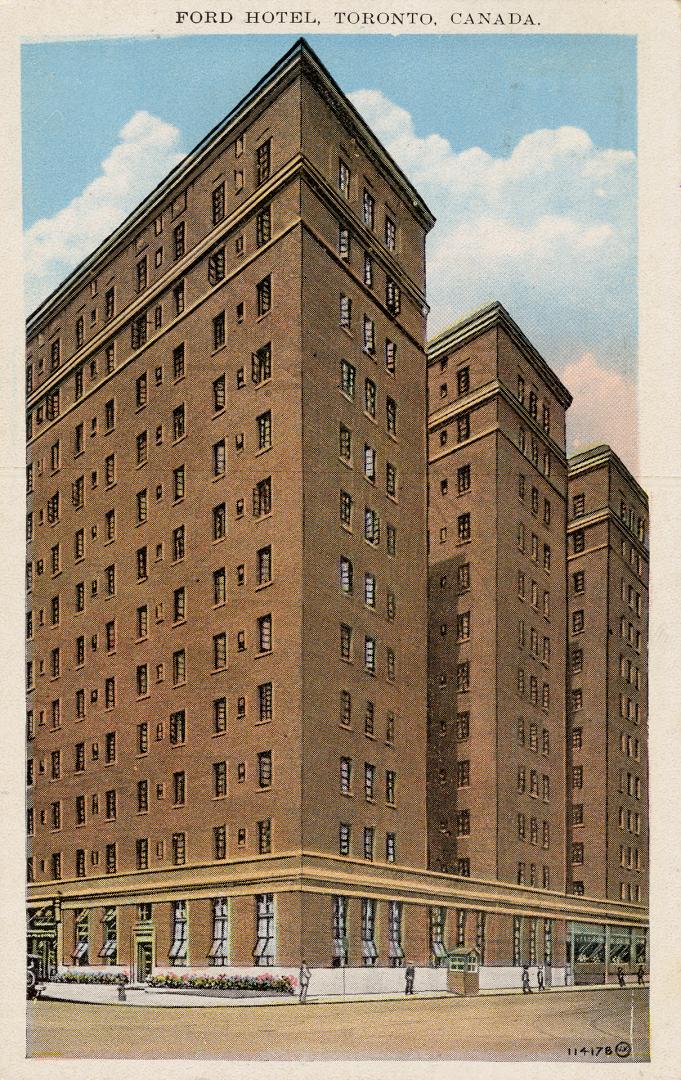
(24, 111, 183, 310)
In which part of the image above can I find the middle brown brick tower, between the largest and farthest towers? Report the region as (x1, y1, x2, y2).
(428, 303, 571, 951)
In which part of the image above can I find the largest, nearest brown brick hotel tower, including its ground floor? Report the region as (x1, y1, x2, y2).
(27, 42, 433, 977)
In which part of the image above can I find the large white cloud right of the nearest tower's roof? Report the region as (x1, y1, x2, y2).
(351, 90, 636, 370)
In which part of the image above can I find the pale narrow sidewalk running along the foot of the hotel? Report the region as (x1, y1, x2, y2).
(40, 983, 649, 1009)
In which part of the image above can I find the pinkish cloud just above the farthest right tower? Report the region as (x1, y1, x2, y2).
(559, 352, 638, 473)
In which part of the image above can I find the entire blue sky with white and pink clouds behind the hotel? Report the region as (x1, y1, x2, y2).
(22, 33, 638, 470)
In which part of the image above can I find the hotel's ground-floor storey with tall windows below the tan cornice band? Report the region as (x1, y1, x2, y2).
(28, 859, 648, 994)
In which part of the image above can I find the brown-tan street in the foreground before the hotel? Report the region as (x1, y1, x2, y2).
(27, 988, 650, 1062)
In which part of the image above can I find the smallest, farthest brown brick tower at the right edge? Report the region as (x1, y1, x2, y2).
(568, 446, 649, 911)
